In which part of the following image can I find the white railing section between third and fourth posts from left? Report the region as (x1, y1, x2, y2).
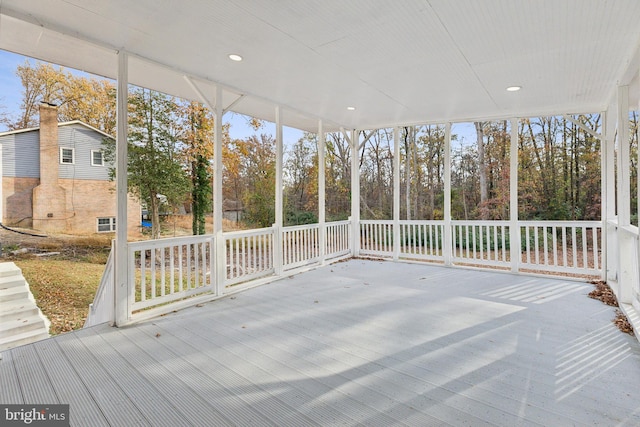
(282, 224, 320, 270)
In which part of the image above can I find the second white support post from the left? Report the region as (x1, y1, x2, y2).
(213, 85, 227, 296)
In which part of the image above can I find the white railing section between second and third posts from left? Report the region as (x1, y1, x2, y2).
(223, 227, 275, 287)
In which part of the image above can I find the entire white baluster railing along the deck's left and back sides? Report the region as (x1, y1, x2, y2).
(86, 220, 604, 325)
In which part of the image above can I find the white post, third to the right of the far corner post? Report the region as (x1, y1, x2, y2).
(509, 118, 521, 273)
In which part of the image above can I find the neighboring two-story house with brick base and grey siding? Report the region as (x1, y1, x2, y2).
(0, 104, 140, 234)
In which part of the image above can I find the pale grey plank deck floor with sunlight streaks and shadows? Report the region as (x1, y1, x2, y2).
(0, 260, 640, 427)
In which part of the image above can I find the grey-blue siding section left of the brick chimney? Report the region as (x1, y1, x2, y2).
(0, 130, 40, 178)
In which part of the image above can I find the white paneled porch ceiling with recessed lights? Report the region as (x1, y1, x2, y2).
(0, 0, 640, 130)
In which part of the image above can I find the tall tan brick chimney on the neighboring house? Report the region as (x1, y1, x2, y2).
(33, 103, 73, 232)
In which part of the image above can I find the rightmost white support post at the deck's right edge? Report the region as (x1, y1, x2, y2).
(617, 86, 638, 303)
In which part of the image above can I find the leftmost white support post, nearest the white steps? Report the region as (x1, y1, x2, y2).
(113, 50, 133, 326)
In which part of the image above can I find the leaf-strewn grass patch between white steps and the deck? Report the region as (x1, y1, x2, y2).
(14, 258, 104, 335)
